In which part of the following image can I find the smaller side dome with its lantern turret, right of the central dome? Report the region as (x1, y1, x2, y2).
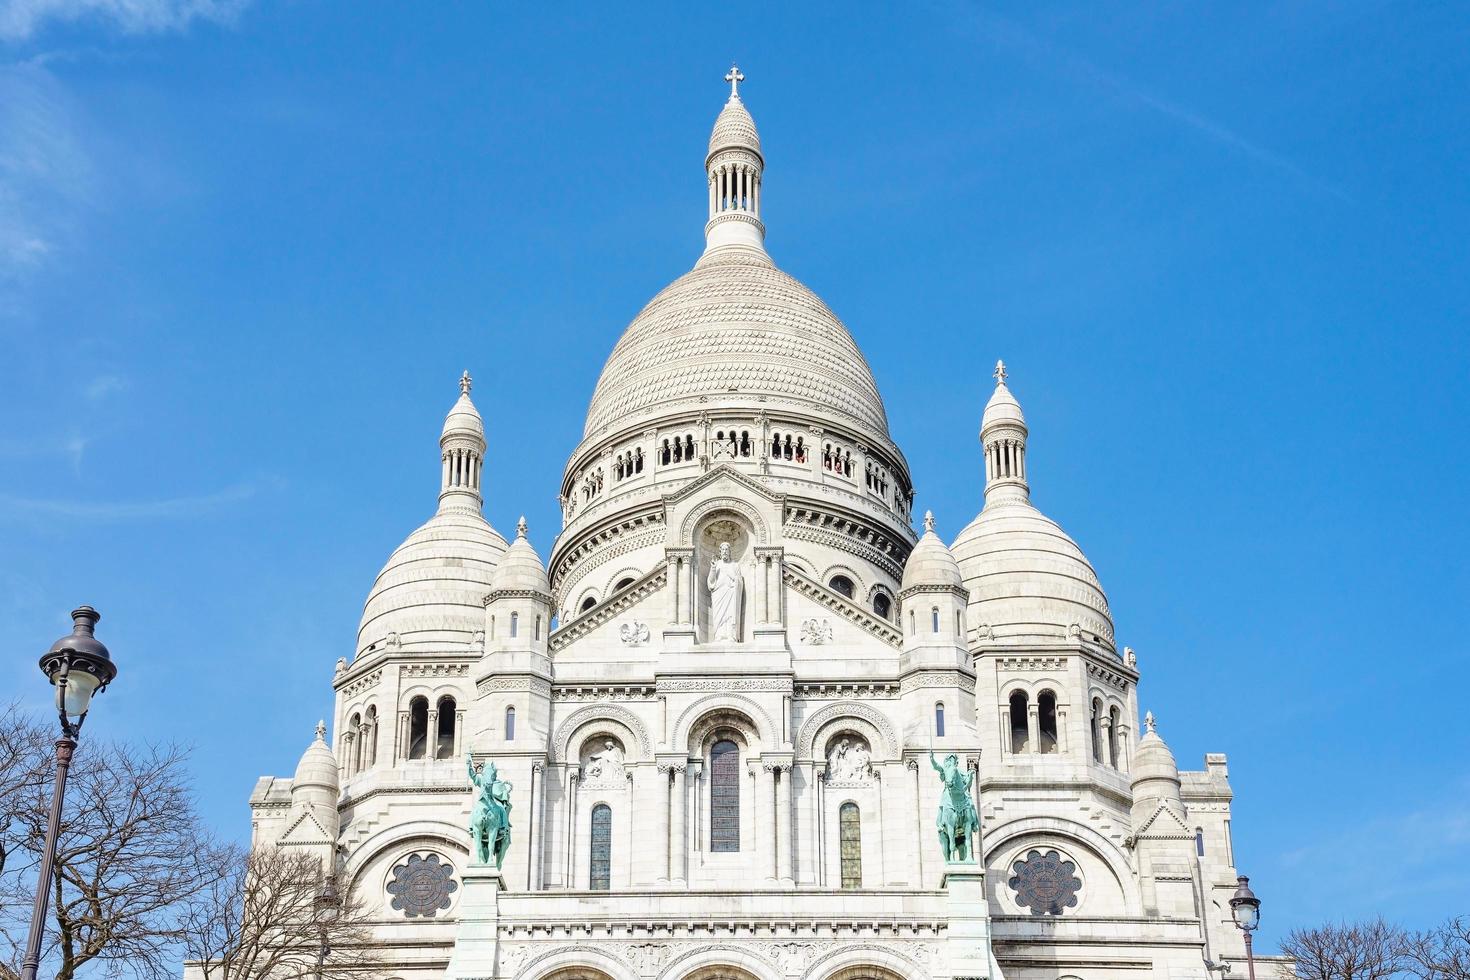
(951, 361, 1116, 652)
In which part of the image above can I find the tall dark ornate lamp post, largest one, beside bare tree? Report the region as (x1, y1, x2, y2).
(21, 605, 118, 980)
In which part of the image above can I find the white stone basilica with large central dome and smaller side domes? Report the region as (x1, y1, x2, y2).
(250, 69, 1270, 980)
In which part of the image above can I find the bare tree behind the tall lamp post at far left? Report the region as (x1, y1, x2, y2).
(0, 741, 219, 980)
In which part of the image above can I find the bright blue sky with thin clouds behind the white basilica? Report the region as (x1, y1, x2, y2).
(0, 0, 1470, 945)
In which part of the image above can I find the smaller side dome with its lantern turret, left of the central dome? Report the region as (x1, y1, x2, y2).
(357, 372, 506, 657)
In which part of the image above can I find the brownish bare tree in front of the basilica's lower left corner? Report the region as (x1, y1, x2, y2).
(184, 846, 384, 980)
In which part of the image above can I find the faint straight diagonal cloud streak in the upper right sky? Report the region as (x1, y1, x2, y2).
(975, 10, 1352, 203)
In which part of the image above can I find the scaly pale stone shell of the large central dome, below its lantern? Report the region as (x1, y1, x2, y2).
(584, 248, 888, 438)
